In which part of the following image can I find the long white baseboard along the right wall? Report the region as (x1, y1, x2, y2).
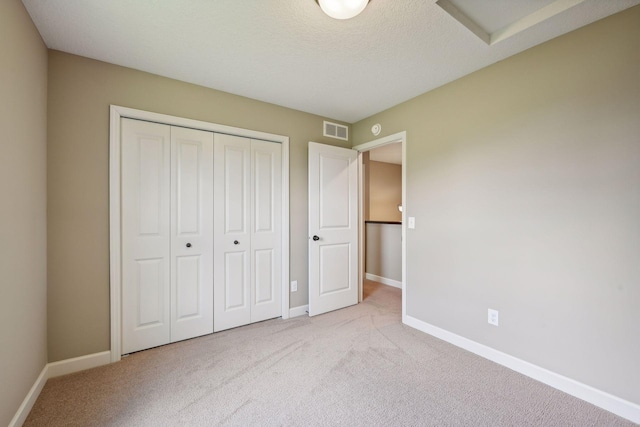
(403, 316, 640, 424)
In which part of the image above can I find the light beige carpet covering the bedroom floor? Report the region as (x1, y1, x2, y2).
(25, 282, 633, 426)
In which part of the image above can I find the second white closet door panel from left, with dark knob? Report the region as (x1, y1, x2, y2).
(171, 127, 213, 342)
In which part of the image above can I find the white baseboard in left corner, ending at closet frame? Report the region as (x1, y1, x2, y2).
(9, 351, 111, 427)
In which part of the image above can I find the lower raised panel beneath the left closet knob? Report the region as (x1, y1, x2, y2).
(175, 255, 202, 321)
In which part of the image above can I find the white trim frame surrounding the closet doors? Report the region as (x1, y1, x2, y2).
(109, 105, 289, 362)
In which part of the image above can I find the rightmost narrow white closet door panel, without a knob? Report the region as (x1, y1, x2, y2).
(251, 140, 282, 322)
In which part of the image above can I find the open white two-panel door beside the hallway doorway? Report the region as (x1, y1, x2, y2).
(309, 142, 358, 316)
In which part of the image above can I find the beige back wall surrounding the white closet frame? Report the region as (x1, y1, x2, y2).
(47, 51, 349, 361)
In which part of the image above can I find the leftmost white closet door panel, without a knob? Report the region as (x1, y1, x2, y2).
(121, 119, 170, 354)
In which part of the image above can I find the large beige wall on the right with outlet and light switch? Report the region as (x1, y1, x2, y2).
(352, 7, 640, 404)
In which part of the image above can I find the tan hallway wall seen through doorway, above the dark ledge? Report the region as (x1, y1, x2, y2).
(368, 160, 402, 221)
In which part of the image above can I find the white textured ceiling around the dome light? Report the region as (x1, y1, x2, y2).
(23, 0, 640, 123)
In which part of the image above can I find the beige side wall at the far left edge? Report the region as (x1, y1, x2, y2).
(0, 0, 47, 426)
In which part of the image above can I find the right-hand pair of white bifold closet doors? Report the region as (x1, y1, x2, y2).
(214, 134, 282, 332)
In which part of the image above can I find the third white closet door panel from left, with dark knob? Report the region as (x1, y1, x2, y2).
(213, 134, 251, 332)
